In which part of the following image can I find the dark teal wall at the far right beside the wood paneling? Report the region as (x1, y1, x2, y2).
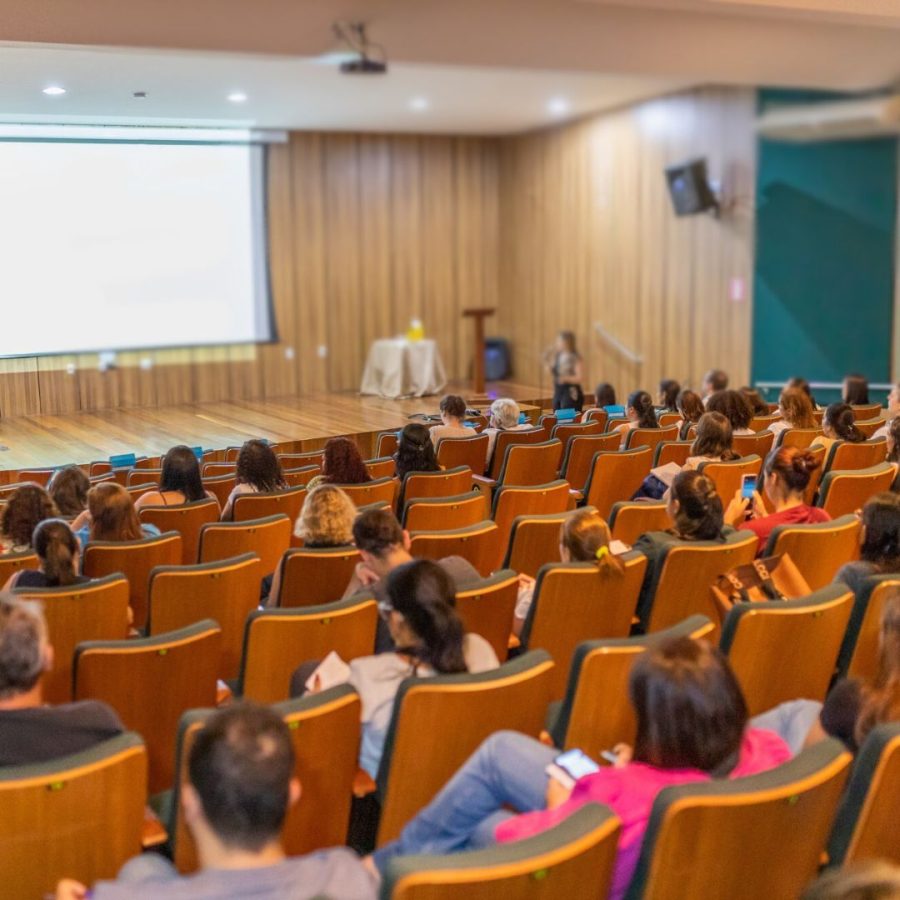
(751, 91, 897, 400)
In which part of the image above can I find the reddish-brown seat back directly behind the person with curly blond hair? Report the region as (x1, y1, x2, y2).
(271, 546, 360, 608)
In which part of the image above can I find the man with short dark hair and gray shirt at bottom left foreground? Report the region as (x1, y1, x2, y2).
(56, 703, 377, 900)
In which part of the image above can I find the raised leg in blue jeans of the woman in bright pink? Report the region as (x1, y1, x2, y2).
(373, 731, 559, 871)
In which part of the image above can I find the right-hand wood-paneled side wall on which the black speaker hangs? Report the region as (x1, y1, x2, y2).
(499, 89, 755, 393)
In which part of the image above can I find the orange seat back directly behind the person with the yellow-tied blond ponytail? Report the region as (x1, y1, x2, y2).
(521, 553, 647, 700)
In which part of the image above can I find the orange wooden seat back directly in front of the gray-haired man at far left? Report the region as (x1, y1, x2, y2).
(13, 574, 128, 703)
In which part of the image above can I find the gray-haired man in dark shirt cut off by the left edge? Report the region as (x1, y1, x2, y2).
(0, 594, 125, 766)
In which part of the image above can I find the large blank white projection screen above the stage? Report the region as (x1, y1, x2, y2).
(0, 134, 274, 357)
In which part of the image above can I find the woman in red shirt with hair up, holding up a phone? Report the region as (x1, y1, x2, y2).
(725, 447, 831, 554)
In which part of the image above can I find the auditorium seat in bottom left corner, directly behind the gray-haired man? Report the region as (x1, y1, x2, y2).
(0, 732, 147, 900)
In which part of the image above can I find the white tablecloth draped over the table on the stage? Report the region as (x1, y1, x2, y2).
(359, 338, 447, 400)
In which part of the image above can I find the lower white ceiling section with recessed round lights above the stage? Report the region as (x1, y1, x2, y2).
(0, 45, 687, 134)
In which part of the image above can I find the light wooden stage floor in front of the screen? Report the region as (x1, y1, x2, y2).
(0, 382, 552, 480)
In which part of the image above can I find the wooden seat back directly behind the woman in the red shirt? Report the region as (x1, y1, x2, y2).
(762, 516, 862, 591)
